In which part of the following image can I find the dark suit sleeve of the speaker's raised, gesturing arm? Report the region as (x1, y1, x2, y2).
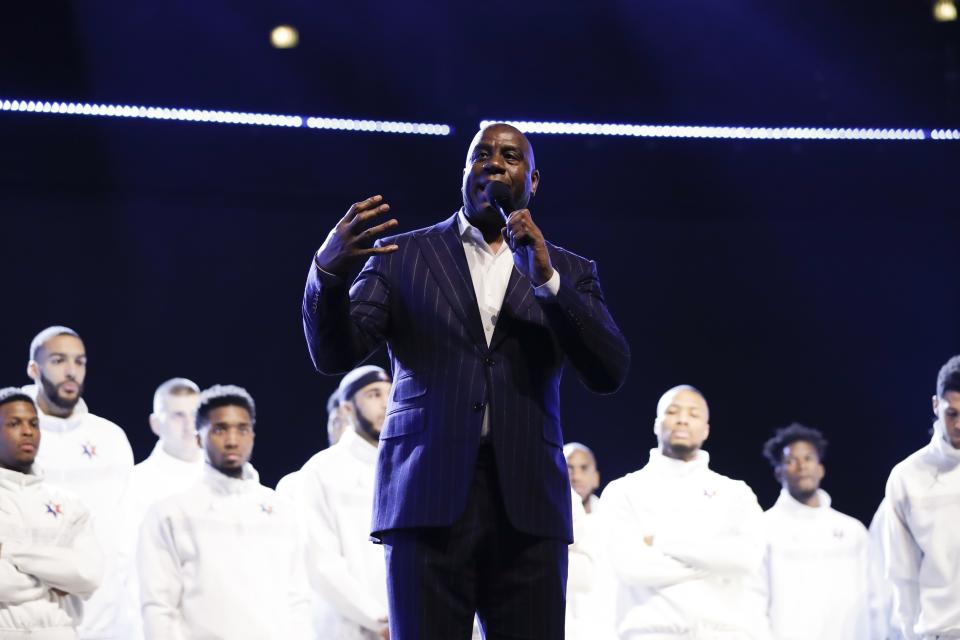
(302, 245, 391, 374)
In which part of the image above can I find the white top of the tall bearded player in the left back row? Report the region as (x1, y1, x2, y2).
(23, 384, 133, 640)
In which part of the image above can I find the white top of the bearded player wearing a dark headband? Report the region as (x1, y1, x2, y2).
(297, 429, 387, 640)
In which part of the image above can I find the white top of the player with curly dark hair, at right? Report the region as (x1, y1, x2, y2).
(761, 490, 877, 640)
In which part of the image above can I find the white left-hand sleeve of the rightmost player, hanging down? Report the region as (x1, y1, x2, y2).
(882, 469, 923, 640)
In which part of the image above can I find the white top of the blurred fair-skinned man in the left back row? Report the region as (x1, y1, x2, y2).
(118, 441, 205, 640)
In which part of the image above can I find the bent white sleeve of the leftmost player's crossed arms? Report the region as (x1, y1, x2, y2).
(4, 510, 103, 598)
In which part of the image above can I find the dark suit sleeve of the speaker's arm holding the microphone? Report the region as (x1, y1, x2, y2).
(536, 253, 630, 393)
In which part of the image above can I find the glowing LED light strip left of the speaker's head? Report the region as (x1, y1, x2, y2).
(0, 99, 451, 136)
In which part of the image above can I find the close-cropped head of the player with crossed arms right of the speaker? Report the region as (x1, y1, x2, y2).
(653, 385, 710, 460)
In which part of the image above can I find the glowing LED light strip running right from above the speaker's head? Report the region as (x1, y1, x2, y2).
(480, 120, 944, 140)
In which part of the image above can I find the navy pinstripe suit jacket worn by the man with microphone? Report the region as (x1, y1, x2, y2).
(303, 215, 630, 542)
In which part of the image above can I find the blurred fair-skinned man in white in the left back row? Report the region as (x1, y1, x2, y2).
(119, 378, 204, 640)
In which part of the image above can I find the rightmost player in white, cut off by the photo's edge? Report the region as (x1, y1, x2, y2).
(883, 356, 960, 640)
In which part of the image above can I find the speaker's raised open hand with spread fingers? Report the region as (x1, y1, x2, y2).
(315, 195, 399, 278)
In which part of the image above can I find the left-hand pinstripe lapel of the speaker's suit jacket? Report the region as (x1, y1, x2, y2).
(416, 215, 487, 347)
